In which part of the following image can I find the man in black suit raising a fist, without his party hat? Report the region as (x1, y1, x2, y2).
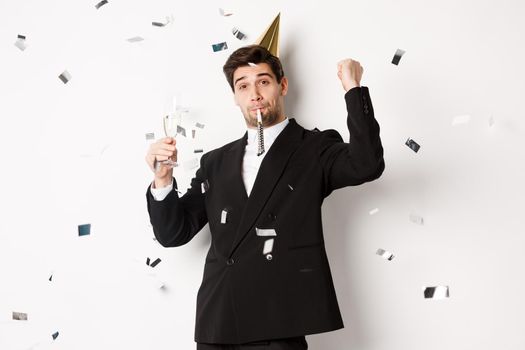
(146, 45, 384, 350)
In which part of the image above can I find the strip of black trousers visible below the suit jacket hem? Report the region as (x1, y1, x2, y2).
(197, 336, 308, 350)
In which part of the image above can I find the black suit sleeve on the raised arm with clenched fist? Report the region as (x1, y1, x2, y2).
(319, 87, 385, 197)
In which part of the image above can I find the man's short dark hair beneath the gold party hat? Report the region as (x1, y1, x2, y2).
(222, 45, 284, 91)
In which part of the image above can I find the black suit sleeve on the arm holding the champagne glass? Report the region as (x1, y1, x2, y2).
(146, 155, 208, 247)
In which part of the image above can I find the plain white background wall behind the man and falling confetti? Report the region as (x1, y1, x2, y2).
(0, 0, 525, 350)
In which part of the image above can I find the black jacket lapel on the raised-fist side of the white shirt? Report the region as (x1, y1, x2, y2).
(229, 119, 303, 255)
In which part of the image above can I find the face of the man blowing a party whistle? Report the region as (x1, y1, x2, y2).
(233, 63, 288, 128)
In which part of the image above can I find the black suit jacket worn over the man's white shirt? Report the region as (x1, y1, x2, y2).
(147, 87, 384, 344)
